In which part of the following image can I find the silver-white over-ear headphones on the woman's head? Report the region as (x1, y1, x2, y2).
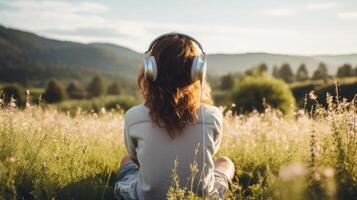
(144, 32, 207, 82)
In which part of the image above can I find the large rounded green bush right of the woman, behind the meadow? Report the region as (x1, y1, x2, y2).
(231, 76, 295, 114)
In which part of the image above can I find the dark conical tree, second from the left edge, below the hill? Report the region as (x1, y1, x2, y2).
(43, 80, 67, 103)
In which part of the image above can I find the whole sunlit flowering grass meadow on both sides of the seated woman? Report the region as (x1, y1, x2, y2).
(0, 93, 357, 199)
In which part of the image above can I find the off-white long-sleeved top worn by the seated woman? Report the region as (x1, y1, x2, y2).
(124, 104, 223, 199)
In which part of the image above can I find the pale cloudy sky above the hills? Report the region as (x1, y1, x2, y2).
(0, 0, 357, 55)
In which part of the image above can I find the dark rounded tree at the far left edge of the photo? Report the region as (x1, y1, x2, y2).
(1, 84, 25, 107)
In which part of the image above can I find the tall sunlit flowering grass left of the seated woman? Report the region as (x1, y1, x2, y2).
(0, 102, 124, 199)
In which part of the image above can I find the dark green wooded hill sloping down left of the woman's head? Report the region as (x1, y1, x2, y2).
(0, 26, 141, 84)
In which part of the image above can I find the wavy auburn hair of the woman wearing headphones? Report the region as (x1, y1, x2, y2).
(138, 35, 213, 138)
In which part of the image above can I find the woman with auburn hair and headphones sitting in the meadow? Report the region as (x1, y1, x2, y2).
(114, 33, 234, 200)
